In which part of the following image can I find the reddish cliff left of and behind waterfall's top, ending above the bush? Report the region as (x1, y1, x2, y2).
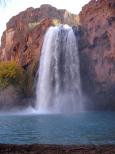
(0, 5, 76, 66)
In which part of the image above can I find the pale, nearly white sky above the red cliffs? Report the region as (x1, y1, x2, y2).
(0, 0, 90, 41)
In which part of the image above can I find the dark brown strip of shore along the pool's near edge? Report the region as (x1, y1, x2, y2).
(0, 144, 115, 154)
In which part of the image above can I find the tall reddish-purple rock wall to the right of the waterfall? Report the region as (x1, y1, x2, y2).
(79, 0, 115, 109)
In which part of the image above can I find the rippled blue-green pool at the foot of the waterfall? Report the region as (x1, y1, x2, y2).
(0, 112, 115, 144)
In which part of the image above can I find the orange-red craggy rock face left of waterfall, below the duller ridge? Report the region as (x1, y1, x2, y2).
(0, 19, 52, 66)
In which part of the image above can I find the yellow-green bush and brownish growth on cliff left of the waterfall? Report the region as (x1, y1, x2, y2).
(0, 61, 37, 97)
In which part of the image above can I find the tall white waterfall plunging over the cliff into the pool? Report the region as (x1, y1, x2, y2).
(36, 25, 82, 113)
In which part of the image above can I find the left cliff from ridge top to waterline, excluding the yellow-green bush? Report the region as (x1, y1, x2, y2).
(0, 4, 77, 109)
